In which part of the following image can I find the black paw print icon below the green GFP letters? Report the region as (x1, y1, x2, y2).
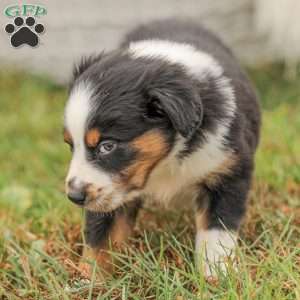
(5, 17, 45, 48)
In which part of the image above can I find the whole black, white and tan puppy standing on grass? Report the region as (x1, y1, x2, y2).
(64, 20, 260, 275)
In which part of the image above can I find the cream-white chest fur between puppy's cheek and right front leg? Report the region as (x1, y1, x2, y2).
(145, 134, 232, 205)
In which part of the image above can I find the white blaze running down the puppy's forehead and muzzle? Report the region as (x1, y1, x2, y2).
(65, 84, 111, 187)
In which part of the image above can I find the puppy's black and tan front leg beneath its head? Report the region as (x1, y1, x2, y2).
(79, 201, 140, 278)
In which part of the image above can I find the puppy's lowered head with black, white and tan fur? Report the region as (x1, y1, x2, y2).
(64, 52, 202, 212)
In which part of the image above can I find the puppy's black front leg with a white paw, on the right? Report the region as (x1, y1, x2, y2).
(196, 172, 251, 277)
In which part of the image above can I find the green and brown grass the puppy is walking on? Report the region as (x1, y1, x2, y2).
(0, 65, 300, 300)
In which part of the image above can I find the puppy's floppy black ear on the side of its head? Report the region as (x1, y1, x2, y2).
(147, 81, 203, 138)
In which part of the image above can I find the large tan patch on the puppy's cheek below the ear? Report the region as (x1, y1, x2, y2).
(121, 130, 168, 188)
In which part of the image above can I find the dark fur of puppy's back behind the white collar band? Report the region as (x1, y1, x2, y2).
(120, 19, 261, 152)
